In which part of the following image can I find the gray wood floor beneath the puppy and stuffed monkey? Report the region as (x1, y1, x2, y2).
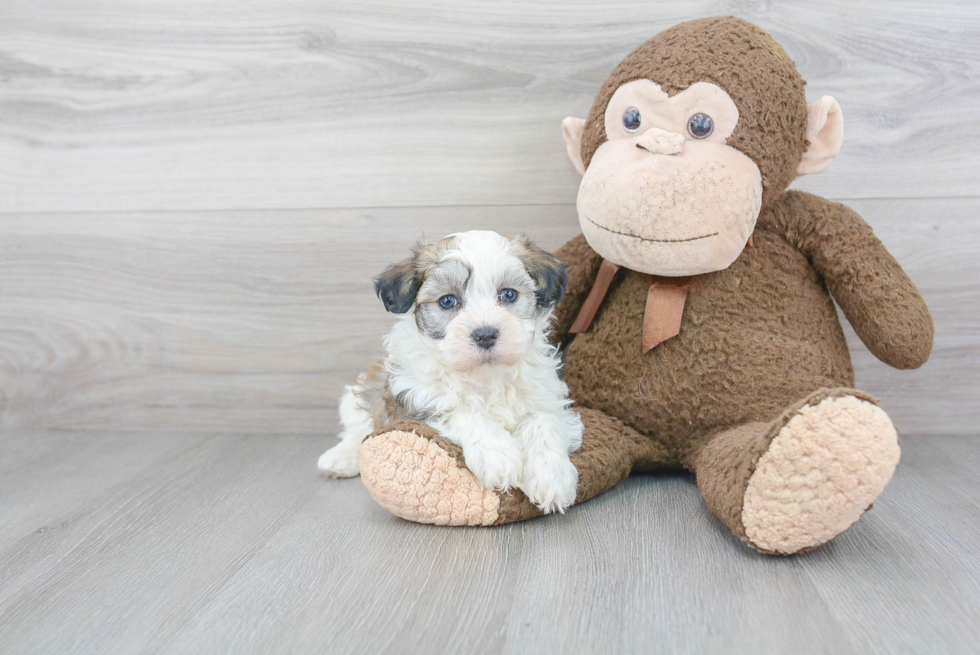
(0, 433, 980, 655)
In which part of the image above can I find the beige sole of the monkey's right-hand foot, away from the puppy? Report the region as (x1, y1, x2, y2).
(742, 396, 900, 554)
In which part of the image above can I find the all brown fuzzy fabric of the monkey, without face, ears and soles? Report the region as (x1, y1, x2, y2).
(354, 17, 933, 550)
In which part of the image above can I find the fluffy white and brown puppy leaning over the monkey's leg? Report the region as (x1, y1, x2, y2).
(319, 231, 582, 512)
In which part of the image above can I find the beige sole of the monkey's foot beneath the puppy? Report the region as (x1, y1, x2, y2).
(361, 430, 500, 525)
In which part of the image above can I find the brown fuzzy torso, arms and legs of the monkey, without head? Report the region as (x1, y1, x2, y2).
(369, 191, 933, 547)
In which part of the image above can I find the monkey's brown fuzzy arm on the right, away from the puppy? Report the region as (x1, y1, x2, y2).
(775, 191, 934, 368)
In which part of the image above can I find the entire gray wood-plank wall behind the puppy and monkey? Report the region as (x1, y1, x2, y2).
(0, 0, 980, 434)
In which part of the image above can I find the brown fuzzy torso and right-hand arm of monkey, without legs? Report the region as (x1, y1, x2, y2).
(558, 192, 932, 459)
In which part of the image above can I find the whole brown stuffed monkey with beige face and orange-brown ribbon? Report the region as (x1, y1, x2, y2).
(361, 17, 933, 554)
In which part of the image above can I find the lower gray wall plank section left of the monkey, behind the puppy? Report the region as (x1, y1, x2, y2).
(0, 207, 572, 432)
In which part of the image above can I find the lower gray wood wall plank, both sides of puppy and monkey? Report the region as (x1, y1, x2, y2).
(0, 199, 968, 434)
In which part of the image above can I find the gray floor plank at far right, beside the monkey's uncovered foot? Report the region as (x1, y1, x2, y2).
(805, 438, 980, 653)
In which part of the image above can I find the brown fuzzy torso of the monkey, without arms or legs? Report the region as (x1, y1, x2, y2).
(565, 220, 854, 460)
